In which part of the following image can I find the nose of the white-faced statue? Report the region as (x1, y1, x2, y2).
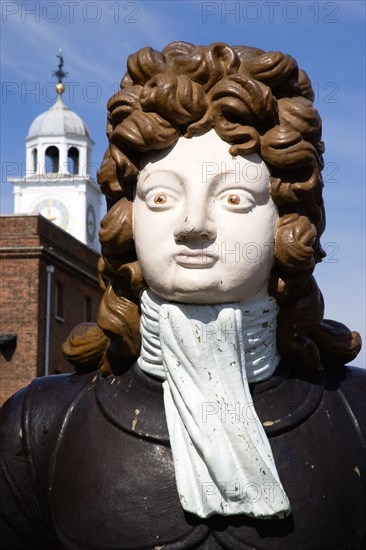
(174, 204, 216, 241)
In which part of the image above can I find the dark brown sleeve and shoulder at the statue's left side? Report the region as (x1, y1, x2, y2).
(0, 373, 97, 549)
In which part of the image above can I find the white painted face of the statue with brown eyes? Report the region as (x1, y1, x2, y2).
(133, 130, 278, 304)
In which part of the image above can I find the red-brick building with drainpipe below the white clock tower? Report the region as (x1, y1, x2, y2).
(0, 215, 102, 404)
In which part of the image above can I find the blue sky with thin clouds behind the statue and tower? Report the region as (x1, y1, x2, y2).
(0, 0, 365, 366)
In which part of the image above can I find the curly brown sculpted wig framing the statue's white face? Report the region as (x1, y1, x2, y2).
(62, 42, 360, 373)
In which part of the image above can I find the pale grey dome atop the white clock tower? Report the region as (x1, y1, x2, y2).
(27, 94, 90, 140)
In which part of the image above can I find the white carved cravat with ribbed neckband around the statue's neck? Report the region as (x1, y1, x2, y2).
(138, 291, 290, 519)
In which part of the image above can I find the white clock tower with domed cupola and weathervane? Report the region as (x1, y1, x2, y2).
(9, 50, 102, 252)
